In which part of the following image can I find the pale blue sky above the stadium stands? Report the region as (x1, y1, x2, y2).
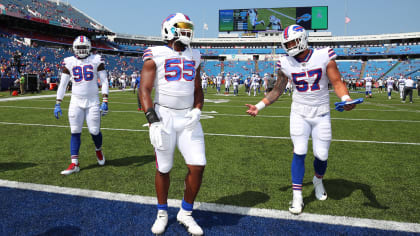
(66, 0, 420, 38)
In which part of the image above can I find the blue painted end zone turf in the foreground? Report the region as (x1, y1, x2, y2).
(0, 187, 420, 236)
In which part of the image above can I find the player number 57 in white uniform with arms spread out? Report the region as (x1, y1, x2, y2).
(246, 25, 355, 214)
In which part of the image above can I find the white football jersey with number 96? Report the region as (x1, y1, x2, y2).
(62, 54, 104, 97)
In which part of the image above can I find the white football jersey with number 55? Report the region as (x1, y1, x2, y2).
(143, 46, 201, 109)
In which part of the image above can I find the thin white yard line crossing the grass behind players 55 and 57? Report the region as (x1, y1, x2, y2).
(0, 121, 420, 146)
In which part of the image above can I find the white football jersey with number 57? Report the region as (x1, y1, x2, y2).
(277, 47, 337, 117)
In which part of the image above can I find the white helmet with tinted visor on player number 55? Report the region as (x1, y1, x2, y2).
(161, 13, 194, 46)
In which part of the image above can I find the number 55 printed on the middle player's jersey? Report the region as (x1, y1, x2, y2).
(165, 58, 195, 81)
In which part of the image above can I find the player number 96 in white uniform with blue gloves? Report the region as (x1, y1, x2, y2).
(54, 36, 109, 175)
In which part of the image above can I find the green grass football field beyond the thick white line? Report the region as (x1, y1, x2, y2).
(0, 88, 420, 223)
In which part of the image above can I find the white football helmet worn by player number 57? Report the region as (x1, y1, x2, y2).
(281, 25, 308, 57)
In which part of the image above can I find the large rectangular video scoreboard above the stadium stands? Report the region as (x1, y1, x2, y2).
(219, 6, 328, 32)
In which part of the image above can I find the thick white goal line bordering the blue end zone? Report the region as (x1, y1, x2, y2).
(0, 179, 420, 233)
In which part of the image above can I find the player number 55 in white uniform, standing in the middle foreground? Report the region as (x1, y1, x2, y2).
(140, 13, 206, 235)
